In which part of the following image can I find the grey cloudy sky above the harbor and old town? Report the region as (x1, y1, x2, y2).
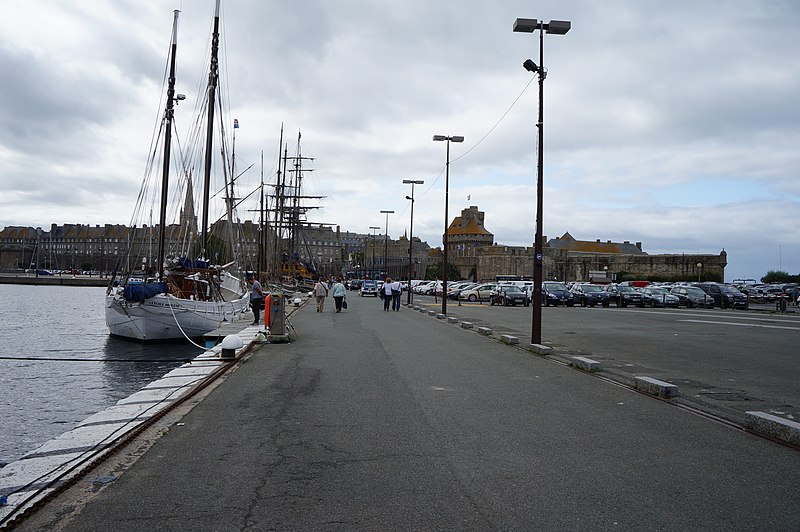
(0, 0, 800, 280)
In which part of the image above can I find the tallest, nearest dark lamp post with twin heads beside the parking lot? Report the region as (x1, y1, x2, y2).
(514, 18, 572, 344)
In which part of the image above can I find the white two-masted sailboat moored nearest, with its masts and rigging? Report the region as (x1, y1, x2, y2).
(105, 0, 251, 342)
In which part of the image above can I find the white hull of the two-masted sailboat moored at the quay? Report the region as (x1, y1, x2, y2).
(106, 288, 252, 342)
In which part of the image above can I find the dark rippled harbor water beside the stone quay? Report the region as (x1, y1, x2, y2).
(0, 285, 201, 465)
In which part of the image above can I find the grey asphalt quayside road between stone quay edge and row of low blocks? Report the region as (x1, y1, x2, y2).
(20, 293, 800, 531)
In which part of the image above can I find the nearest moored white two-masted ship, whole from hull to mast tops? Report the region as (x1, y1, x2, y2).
(105, 0, 251, 342)
